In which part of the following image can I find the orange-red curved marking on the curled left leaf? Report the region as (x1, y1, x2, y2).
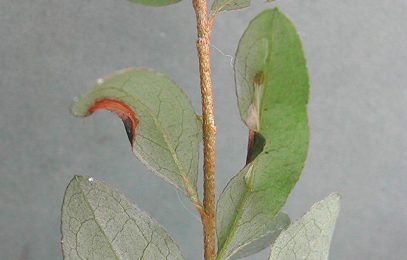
(89, 98, 139, 146)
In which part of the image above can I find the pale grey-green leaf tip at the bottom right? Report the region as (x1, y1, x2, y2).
(270, 193, 341, 260)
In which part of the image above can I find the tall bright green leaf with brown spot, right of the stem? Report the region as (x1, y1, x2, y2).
(217, 9, 309, 259)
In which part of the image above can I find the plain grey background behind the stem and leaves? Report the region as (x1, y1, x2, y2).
(0, 0, 407, 260)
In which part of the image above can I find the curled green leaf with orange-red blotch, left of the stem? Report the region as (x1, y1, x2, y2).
(71, 68, 202, 199)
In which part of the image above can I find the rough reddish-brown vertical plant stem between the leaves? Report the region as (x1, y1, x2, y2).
(193, 0, 216, 260)
